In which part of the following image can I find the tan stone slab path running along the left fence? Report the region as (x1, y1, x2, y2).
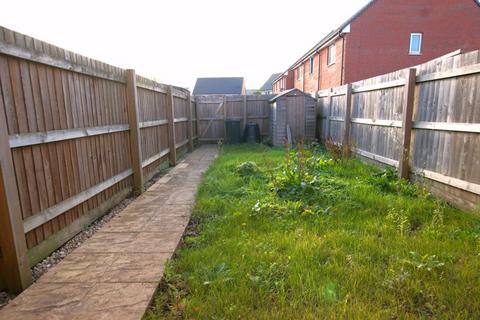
(0, 146, 217, 320)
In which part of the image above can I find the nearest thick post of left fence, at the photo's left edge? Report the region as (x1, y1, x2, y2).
(0, 107, 32, 293)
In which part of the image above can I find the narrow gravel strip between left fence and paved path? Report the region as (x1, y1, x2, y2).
(0, 168, 170, 310)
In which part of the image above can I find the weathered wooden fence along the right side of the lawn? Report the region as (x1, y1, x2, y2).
(317, 51, 480, 208)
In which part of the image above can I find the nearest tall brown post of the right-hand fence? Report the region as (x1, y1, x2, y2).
(398, 68, 417, 180)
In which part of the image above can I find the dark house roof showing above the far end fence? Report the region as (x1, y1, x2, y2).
(193, 77, 244, 95)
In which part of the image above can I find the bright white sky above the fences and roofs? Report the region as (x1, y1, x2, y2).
(0, 0, 368, 89)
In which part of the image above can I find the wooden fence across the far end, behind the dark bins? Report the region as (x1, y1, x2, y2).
(195, 95, 273, 143)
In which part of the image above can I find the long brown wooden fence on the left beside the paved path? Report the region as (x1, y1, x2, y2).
(0, 28, 197, 292)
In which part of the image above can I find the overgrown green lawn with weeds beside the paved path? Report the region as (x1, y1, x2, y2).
(145, 146, 480, 319)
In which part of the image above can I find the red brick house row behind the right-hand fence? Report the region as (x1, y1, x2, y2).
(273, 0, 480, 93)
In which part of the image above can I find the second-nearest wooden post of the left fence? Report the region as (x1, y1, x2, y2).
(127, 69, 143, 195)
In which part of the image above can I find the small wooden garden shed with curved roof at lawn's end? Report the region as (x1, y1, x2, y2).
(270, 89, 316, 146)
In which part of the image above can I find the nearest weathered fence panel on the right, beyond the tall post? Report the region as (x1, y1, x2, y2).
(412, 51, 480, 207)
